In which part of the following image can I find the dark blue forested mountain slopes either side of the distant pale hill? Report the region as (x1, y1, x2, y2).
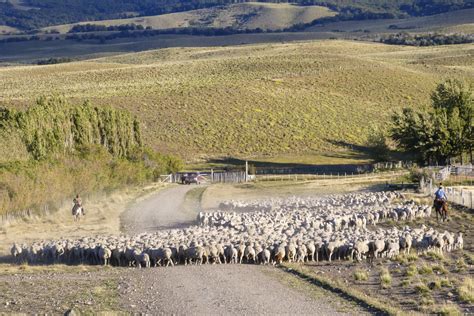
(0, 0, 474, 30)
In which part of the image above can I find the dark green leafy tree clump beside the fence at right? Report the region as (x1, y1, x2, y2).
(391, 80, 474, 163)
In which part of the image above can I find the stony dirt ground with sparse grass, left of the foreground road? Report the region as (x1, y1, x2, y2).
(0, 266, 119, 314)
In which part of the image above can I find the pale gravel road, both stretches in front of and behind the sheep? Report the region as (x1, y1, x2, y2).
(115, 185, 362, 315)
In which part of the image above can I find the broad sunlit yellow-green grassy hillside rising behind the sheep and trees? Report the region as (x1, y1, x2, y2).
(0, 41, 474, 163)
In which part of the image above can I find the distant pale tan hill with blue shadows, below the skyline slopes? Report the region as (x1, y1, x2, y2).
(44, 2, 336, 33)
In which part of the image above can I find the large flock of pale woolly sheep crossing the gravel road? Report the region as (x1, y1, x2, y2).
(11, 192, 463, 267)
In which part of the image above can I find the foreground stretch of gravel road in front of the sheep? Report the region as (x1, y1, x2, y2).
(119, 265, 350, 315)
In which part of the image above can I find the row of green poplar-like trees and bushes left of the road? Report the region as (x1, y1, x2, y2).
(0, 97, 182, 214)
